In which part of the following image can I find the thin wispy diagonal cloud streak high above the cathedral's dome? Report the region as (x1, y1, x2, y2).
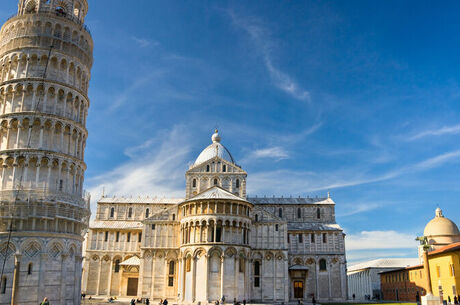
(228, 11, 310, 101)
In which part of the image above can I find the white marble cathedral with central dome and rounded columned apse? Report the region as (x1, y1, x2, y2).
(82, 131, 347, 304)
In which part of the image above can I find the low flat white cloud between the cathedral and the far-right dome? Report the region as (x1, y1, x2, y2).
(345, 230, 418, 251)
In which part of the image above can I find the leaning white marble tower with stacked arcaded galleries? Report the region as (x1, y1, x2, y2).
(0, 0, 93, 305)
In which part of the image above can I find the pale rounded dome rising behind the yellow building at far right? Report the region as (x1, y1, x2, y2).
(423, 208, 460, 244)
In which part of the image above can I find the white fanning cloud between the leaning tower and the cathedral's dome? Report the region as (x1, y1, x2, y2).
(87, 126, 190, 213)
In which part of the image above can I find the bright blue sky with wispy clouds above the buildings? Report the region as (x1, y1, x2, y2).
(0, 0, 460, 262)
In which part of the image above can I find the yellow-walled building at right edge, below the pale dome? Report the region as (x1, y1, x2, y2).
(428, 242, 460, 302)
